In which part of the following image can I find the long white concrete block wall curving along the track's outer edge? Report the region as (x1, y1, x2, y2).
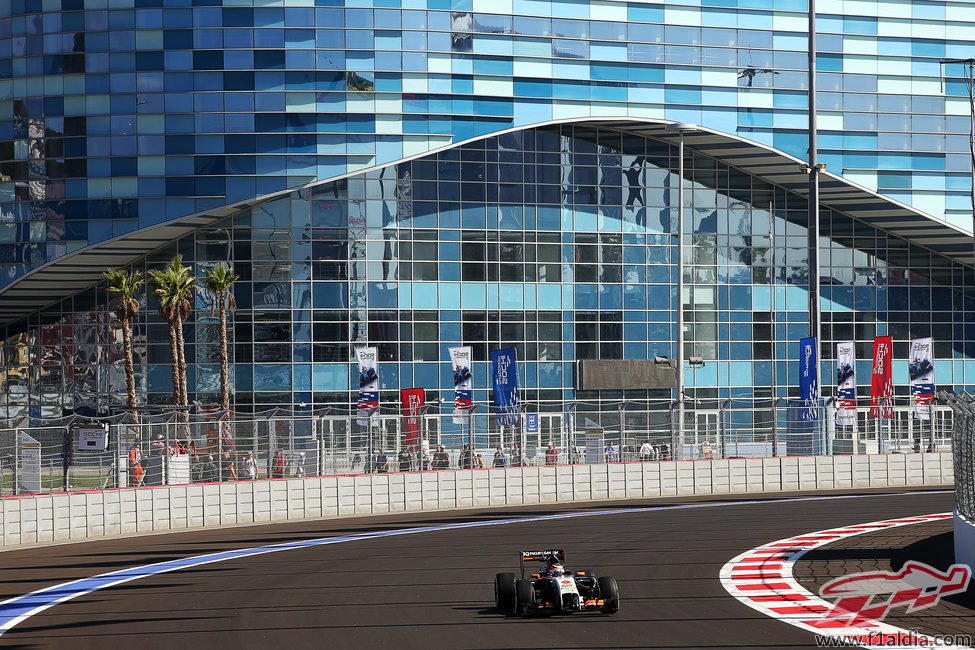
(0, 453, 953, 547)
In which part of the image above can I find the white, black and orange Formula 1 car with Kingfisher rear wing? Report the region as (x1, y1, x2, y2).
(494, 549, 620, 617)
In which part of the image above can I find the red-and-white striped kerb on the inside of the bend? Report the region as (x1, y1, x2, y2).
(720, 512, 965, 648)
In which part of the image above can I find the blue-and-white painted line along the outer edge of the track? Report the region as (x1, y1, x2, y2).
(0, 490, 953, 636)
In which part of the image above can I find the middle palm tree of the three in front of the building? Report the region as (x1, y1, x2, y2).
(149, 255, 196, 421)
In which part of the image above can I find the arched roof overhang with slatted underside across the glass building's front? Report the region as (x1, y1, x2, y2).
(0, 117, 975, 324)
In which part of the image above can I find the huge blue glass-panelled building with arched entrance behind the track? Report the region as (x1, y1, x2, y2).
(0, 0, 975, 417)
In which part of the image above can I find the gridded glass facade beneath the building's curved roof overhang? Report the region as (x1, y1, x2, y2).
(4, 125, 975, 412)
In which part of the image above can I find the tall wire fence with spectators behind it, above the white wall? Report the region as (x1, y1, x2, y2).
(0, 400, 956, 496)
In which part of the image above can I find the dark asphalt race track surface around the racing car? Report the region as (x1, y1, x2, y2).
(0, 490, 954, 650)
